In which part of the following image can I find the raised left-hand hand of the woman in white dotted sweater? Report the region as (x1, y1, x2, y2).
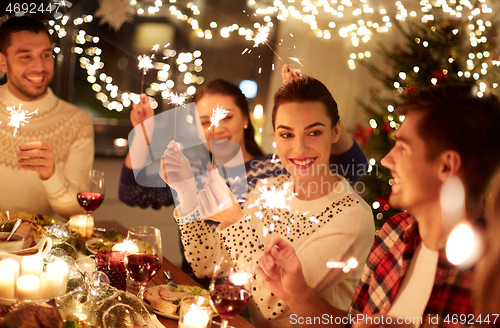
(160, 140, 198, 216)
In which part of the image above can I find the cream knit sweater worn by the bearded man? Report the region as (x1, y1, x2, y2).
(0, 85, 94, 217)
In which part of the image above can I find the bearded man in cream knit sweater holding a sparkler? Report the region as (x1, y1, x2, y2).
(0, 16, 94, 217)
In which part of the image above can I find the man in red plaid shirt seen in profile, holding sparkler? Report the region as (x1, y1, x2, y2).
(258, 85, 500, 327)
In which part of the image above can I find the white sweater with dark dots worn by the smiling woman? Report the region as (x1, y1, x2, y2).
(174, 175, 375, 328)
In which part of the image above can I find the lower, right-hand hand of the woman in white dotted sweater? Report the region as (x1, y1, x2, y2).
(198, 163, 243, 229)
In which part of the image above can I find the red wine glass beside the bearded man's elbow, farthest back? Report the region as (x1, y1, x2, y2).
(76, 170, 104, 232)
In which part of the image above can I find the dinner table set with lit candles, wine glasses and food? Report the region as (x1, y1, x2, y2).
(0, 172, 252, 328)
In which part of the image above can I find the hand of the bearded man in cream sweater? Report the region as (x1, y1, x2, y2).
(16, 141, 56, 180)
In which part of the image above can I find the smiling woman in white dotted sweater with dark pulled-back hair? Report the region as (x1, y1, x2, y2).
(162, 77, 374, 327)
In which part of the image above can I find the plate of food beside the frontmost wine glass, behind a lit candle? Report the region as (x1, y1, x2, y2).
(144, 285, 210, 316)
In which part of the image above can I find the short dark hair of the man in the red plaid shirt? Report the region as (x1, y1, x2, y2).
(398, 84, 500, 200)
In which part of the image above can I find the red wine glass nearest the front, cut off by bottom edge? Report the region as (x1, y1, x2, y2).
(209, 255, 253, 328)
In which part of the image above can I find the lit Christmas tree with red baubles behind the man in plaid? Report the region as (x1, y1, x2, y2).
(354, 0, 500, 229)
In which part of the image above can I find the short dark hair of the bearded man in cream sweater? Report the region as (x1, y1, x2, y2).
(0, 16, 52, 55)
